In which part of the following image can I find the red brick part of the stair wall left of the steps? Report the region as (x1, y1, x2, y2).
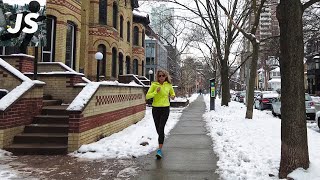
(0, 98, 43, 129)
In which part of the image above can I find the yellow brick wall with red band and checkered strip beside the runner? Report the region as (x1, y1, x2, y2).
(68, 85, 146, 151)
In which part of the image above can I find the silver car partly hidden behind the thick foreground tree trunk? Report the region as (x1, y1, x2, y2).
(272, 93, 317, 120)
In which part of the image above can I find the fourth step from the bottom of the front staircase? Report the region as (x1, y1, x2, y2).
(33, 115, 69, 124)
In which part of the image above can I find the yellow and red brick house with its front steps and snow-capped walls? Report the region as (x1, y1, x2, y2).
(0, 0, 149, 154)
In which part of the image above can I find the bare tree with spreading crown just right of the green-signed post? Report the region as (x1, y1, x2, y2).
(169, 0, 249, 106)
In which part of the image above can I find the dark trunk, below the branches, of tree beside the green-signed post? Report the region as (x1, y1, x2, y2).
(221, 58, 230, 106)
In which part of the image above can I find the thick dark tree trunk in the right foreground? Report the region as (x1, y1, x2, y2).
(277, 0, 309, 178)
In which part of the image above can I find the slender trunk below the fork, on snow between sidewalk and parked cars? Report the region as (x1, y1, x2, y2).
(246, 40, 259, 119)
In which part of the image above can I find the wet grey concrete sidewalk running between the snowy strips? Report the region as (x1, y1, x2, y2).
(136, 96, 219, 180)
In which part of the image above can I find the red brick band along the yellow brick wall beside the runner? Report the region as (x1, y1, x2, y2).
(69, 104, 146, 133)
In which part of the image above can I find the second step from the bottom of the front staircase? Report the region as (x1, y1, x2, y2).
(13, 133, 68, 144)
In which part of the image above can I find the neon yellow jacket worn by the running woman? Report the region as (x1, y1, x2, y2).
(146, 81, 176, 107)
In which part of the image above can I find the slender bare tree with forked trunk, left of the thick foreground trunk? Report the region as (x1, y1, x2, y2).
(217, 0, 266, 119)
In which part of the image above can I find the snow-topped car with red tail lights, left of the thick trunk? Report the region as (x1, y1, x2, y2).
(254, 91, 279, 110)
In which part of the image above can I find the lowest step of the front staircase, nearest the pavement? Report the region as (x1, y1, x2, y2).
(5, 143, 68, 155)
